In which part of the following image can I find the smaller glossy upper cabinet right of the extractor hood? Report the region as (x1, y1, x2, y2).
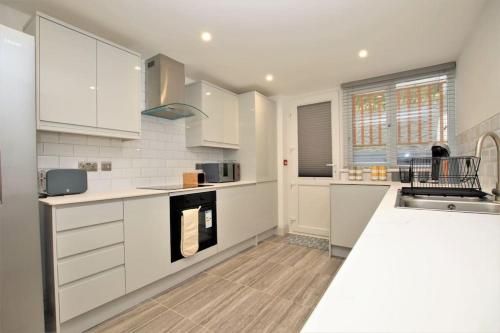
(186, 81, 239, 149)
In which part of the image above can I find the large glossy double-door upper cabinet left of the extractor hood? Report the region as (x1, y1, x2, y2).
(26, 13, 141, 139)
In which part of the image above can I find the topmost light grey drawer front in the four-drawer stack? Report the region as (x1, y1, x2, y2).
(56, 201, 123, 231)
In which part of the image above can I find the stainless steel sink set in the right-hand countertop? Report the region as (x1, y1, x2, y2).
(396, 192, 500, 214)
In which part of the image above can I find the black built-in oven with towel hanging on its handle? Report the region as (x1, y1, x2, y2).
(170, 191, 217, 262)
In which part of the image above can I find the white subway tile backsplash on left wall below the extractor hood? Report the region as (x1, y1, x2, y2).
(37, 116, 223, 191)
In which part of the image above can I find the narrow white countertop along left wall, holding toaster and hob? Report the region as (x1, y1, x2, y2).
(39, 181, 256, 206)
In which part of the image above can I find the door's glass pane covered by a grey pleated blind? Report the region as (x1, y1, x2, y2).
(297, 102, 332, 177)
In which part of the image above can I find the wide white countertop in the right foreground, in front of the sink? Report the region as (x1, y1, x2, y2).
(302, 184, 500, 332)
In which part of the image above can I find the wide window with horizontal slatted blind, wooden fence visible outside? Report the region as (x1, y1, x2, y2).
(342, 63, 455, 166)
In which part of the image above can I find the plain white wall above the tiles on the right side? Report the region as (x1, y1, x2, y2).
(456, 0, 500, 134)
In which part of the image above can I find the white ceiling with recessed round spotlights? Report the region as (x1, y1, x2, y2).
(0, 0, 484, 94)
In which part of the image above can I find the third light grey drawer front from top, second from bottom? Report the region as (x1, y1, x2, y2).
(57, 244, 125, 286)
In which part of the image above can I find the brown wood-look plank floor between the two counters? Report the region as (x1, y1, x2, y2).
(90, 236, 342, 333)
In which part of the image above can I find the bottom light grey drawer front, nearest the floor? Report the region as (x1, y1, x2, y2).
(59, 266, 125, 323)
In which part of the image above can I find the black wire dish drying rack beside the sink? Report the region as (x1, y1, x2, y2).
(399, 156, 487, 197)
